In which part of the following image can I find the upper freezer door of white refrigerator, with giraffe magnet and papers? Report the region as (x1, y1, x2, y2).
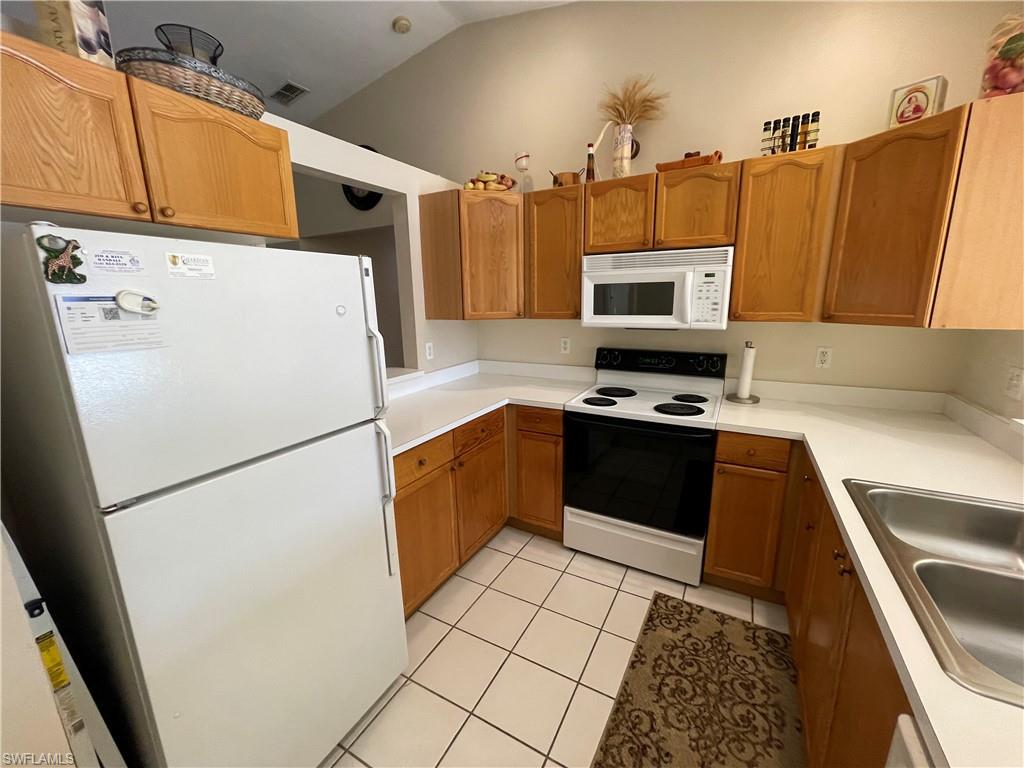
(29, 226, 381, 507)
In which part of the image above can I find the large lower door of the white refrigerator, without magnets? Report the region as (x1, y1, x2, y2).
(104, 424, 407, 766)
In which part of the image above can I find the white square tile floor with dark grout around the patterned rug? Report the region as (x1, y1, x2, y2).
(335, 527, 788, 768)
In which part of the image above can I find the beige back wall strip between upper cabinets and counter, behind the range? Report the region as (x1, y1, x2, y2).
(477, 321, 967, 391)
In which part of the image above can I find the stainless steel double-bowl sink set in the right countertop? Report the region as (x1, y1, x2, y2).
(844, 479, 1024, 707)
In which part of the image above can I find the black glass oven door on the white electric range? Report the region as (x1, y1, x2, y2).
(564, 411, 717, 539)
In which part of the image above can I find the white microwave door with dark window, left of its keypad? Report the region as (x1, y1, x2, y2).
(582, 268, 693, 329)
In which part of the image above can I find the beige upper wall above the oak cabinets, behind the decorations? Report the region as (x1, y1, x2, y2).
(312, 2, 1020, 187)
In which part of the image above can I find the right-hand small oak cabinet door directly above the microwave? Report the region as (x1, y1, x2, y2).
(654, 163, 742, 248)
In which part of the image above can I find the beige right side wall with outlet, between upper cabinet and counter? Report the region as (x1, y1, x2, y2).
(952, 331, 1024, 419)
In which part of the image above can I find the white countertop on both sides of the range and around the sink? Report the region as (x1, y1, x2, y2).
(387, 374, 1024, 766)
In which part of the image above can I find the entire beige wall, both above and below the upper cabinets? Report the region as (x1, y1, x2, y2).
(313, 2, 1021, 393)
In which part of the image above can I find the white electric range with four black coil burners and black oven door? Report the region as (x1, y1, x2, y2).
(563, 347, 726, 584)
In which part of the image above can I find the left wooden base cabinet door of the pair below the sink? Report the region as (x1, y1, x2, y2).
(798, 512, 853, 765)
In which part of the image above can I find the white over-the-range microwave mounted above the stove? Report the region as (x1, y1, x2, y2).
(582, 246, 732, 331)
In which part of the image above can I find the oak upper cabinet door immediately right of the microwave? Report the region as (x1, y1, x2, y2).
(730, 146, 842, 323)
